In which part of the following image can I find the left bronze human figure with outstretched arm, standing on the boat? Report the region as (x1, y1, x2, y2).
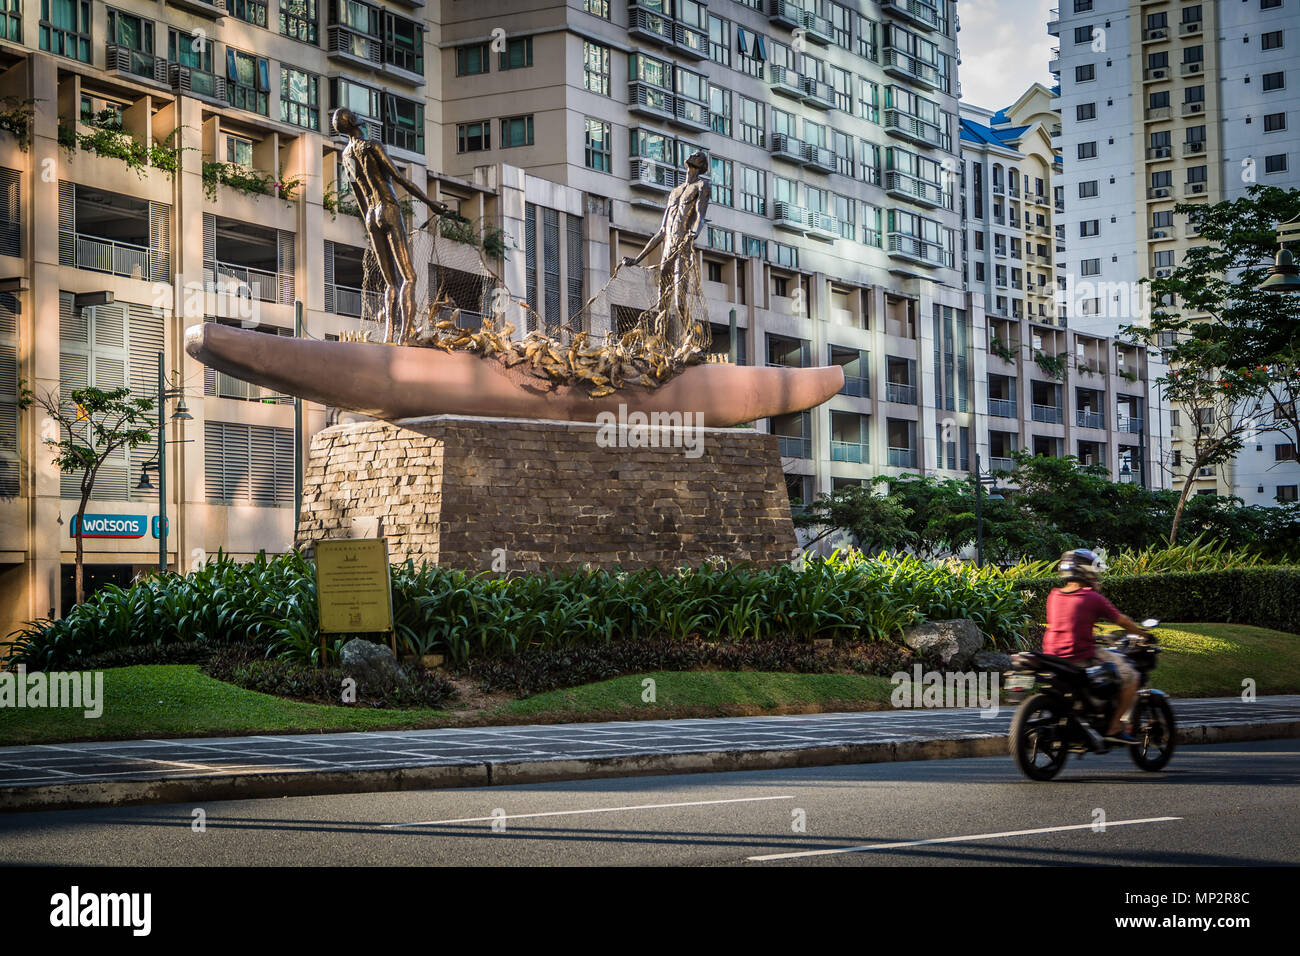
(333, 108, 465, 345)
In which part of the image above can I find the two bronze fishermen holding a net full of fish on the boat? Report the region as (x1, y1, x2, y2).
(334, 104, 711, 398)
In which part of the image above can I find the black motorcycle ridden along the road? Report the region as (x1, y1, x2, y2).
(1006, 619, 1175, 780)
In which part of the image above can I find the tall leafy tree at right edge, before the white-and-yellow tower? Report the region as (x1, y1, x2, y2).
(1125, 185, 1300, 542)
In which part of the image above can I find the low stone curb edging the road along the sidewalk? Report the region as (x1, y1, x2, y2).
(0, 721, 1300, 813)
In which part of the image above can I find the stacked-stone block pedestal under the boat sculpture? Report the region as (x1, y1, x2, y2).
(298, 416, 796, 572)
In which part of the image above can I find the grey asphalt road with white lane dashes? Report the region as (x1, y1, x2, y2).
(0, 740, 1300, 868)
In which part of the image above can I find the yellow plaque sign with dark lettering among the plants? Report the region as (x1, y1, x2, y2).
(316, 538, 393, 635)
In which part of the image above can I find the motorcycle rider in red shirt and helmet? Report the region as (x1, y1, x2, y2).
(1043, 548, 1149, 744)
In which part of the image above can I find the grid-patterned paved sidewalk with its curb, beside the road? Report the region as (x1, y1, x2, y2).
(0, 696, 1300, 810)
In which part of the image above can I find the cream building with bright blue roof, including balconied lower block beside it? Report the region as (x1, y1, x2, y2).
(961, 83, 1167, 486)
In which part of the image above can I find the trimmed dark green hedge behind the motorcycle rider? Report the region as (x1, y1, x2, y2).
(1017, 566, 1300, 633)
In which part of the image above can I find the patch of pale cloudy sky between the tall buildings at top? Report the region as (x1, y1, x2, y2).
(957, 0, 1061, 109)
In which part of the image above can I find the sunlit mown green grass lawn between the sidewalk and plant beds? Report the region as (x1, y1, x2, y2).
(0, 624, 1300, 745)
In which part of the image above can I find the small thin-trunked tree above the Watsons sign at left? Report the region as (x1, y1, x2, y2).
(21, 388, 153, 604)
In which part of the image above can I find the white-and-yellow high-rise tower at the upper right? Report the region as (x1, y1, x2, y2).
(1049, 0, 1300, 505)
